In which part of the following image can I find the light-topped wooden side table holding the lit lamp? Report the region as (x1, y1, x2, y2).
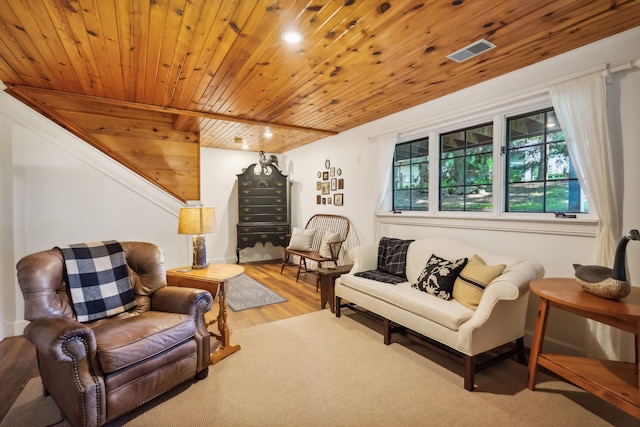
(167, 264, 244, 365)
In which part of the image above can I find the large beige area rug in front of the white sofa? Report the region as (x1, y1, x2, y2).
(2, 310, 639, 427)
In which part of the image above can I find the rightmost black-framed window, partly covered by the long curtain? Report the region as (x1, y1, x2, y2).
(505, 108, 588, 213)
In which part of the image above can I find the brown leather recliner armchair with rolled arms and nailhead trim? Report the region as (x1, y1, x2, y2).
(17, 242, 214, 426)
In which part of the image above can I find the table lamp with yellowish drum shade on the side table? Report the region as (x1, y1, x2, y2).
(178, 206, 216, 270)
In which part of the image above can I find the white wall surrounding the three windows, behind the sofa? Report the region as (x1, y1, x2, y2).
(285, 27, 640, 353)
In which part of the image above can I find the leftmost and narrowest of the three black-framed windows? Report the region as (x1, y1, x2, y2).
(393, 138, 429, 211)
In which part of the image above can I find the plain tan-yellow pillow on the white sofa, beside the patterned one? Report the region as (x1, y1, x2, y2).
(453, 255, 506, 310)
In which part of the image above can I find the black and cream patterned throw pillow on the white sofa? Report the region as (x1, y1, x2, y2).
(411, 254, 467, 300)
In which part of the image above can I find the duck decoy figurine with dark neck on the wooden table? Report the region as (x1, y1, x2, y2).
(573, 230, 640, 299)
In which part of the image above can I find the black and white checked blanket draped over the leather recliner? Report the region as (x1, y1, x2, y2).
(58, 240, 136, 322)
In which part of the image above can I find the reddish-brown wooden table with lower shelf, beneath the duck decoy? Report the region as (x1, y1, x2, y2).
(528, 278, 640, 418)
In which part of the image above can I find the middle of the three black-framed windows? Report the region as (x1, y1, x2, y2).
(440, 123, 493, 211)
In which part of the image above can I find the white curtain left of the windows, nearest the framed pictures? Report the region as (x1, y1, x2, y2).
(370, 132, 398, 240)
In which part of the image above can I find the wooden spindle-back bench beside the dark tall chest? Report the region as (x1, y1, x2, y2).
(280, 214, 350, 291)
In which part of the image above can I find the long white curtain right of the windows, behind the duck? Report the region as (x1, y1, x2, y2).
(550, 72, 632, 360)
